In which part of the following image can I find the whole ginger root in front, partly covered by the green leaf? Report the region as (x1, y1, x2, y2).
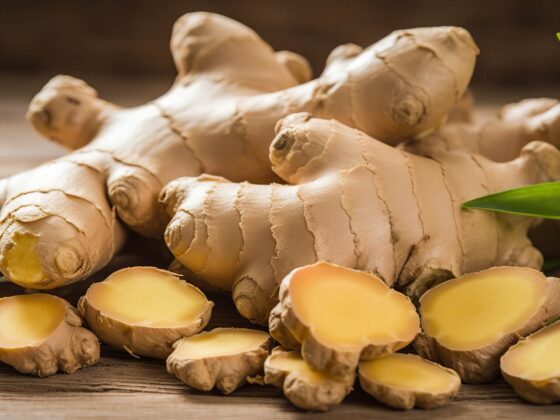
(162, 113, 560, 323)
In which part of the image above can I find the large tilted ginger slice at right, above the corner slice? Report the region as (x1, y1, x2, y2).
(414, 267, 560, 383)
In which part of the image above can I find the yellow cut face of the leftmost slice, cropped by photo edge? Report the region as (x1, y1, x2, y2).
(0, 294, 67, 349)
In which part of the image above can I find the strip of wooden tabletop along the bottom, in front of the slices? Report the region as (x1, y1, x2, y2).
(0, 347, 560, 419)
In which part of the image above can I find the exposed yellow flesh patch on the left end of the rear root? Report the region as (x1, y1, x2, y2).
(4, 232, 44, 288)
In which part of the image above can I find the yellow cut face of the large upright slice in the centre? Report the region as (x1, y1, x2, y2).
(289, 263, 418, 348)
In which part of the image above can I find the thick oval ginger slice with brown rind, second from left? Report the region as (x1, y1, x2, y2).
(78, 267, 214, 359)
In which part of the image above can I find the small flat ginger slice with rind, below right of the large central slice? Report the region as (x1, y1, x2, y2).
(359, 353, 461, 410)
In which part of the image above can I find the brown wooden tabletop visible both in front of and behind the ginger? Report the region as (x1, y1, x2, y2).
(0, 75, 560, 420)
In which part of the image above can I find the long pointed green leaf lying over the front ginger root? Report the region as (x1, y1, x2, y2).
(463, 181, 560, 220)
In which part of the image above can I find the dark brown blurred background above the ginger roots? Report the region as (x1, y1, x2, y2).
(0, 0, 560, 174)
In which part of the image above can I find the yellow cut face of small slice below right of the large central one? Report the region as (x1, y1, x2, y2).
(359, 353, 460, 394)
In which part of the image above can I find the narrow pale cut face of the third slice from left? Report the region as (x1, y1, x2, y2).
(174, 328, 269, 360)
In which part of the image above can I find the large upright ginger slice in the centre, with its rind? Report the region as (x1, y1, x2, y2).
(275, 262, 420, 375)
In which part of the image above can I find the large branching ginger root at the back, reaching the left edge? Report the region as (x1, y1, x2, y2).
(0, 13, 478, 289)
